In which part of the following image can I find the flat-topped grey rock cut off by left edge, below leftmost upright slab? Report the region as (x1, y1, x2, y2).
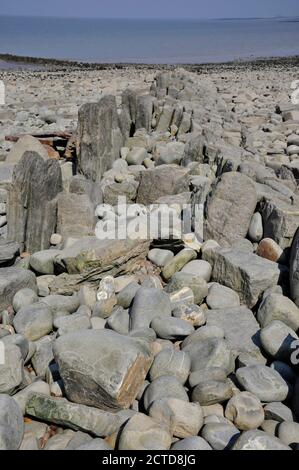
(0, 267, 37, 311)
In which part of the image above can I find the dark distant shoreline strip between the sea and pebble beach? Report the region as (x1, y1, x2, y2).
(0, 53, 299, 71)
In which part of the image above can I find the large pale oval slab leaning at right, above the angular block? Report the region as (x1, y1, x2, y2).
(204, 172, 257, 246)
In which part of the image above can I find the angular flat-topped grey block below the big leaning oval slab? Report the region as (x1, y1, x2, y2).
(203, 249, 280, 308)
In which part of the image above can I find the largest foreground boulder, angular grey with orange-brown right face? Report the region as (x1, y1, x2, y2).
(53, 330, 153, 410)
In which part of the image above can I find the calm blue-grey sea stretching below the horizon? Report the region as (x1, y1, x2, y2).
(0, 17, 299, 63)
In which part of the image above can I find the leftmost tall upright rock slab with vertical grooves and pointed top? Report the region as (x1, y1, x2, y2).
(7, 152, 62, 253)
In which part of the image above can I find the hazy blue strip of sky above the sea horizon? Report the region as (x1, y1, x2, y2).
(0, 0, 299, 19)
